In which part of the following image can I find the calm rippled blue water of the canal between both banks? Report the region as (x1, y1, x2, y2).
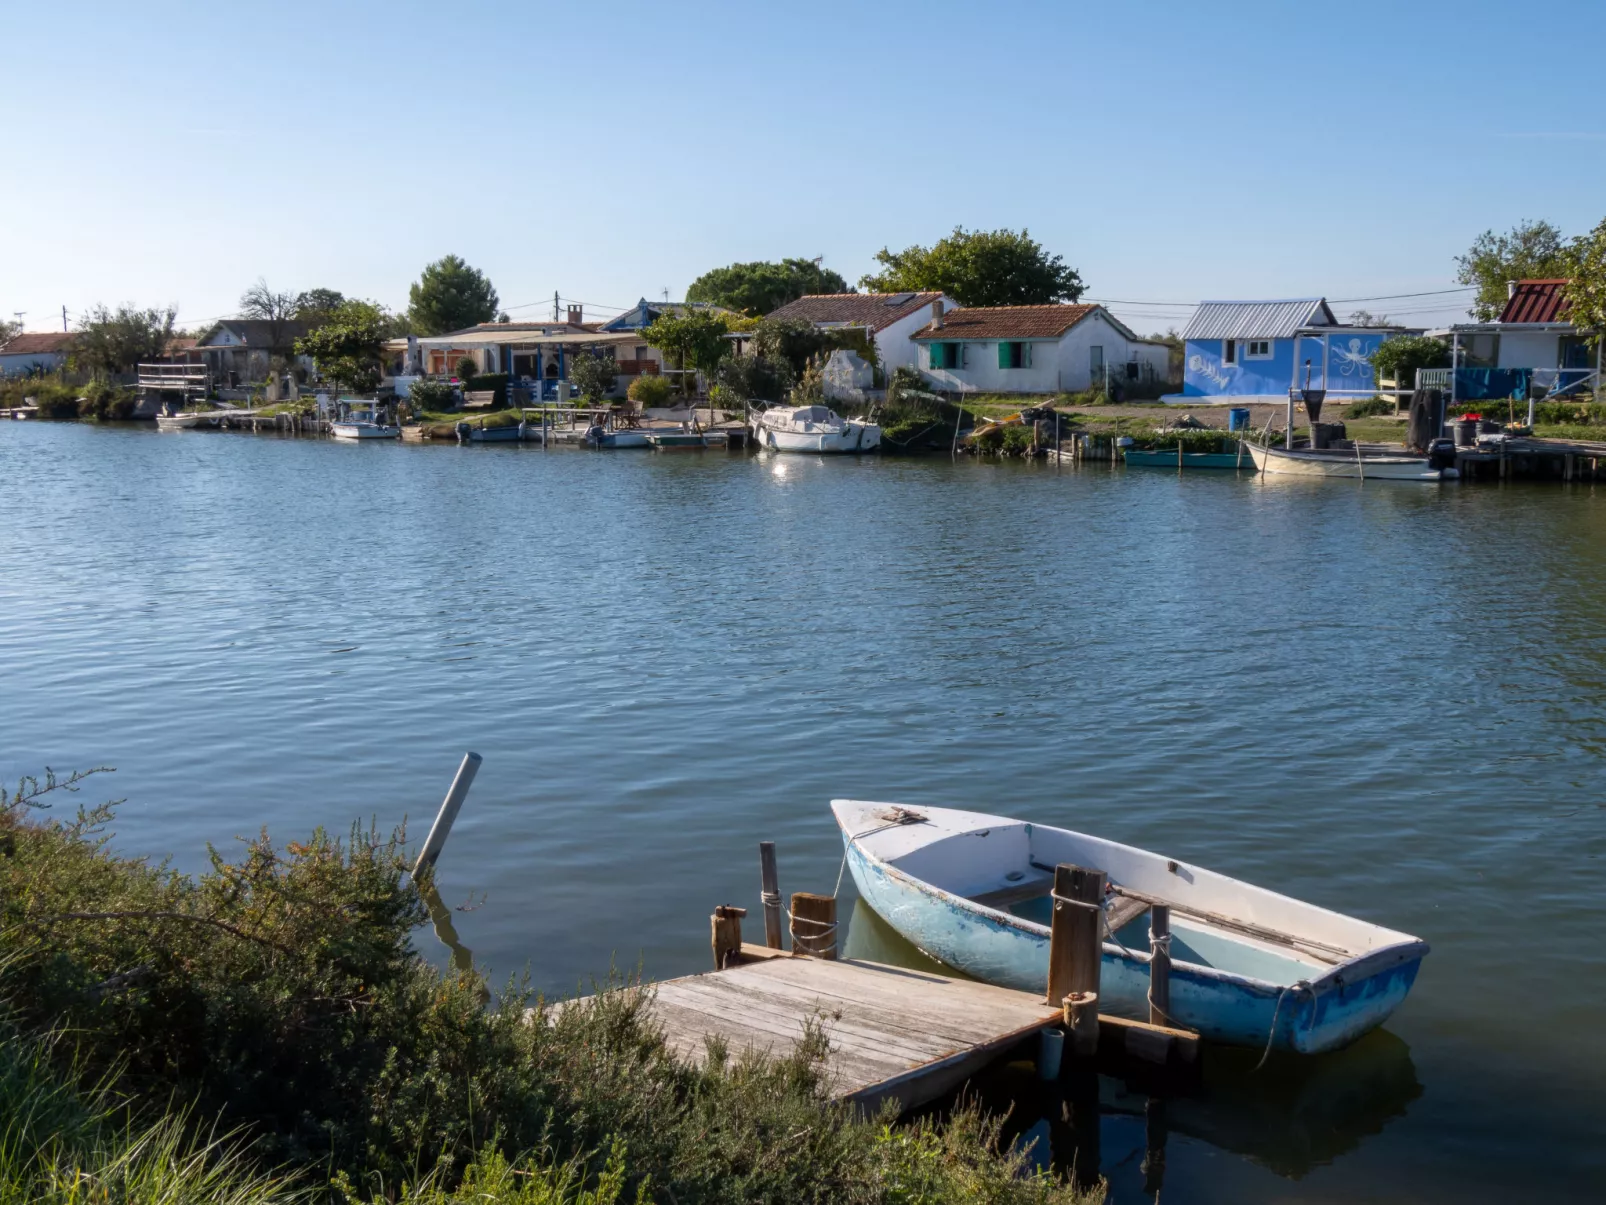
(0, 423, 1606, 1202)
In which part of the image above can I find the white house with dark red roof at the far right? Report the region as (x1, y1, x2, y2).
(1429, 280, 1606, 402)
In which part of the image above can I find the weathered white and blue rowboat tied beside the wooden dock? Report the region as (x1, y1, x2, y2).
(830, 799, 1428, 1054)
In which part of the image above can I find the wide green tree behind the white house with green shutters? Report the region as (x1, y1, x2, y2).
(859, 227, 1084, 305)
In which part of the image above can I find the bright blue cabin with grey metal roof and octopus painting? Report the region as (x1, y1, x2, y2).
(1172, 297, 1404, 402)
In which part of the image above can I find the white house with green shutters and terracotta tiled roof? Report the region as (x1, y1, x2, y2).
(914, 305, 1171, 395)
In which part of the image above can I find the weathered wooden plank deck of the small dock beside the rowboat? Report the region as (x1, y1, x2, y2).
(639, 945, 1060, 1110)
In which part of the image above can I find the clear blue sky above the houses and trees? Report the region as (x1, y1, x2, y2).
(0, 0, 1606, 331)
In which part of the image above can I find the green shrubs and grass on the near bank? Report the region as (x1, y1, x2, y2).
(0, 771, 1103, 1205)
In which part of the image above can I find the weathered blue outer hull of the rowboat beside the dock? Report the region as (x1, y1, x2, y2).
(843, 834, 1425, 1054)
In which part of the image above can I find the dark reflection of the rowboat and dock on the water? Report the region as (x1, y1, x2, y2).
(843, 900, 1421, 1199)
